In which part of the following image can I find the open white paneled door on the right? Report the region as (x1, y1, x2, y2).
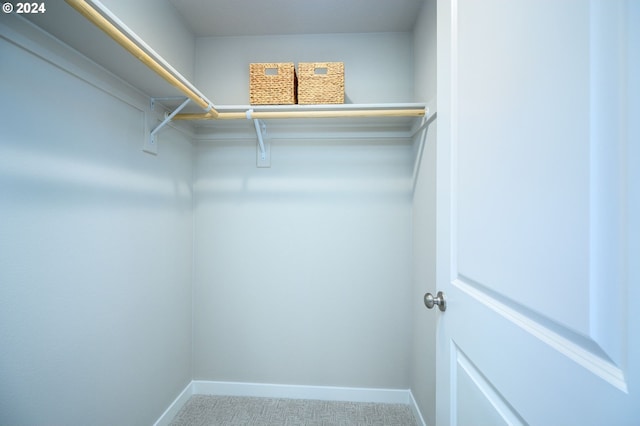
(433, 0, 640, 425)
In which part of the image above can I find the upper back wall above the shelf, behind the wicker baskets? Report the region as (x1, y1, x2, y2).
(195, 33, 413, 105)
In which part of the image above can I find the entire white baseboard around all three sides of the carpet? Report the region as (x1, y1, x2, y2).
(154, 380, 426, 426)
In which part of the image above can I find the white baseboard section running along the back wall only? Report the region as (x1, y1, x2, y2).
(192, 380, 409, 404)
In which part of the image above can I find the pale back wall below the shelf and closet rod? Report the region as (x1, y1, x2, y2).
(194, 138, 412, 389)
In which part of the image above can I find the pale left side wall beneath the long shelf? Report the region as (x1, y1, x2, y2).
(0, 17, 192, 425)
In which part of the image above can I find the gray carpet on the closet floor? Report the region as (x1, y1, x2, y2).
(171, 395, 417, 426)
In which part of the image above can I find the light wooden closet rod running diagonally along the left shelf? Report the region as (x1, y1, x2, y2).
(65, 0, 219, 119)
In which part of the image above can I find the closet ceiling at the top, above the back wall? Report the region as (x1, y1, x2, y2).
(169, 0, 423, 37)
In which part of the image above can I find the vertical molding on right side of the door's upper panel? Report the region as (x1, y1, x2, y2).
(589, 0, 629, 370)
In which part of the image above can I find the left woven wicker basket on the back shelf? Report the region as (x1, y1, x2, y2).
(249, 62, 298, 105)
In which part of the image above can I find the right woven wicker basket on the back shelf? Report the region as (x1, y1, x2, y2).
(298, 62, 344, 105)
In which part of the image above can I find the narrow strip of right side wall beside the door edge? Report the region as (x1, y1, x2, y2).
(411, 0, 440, 425)
